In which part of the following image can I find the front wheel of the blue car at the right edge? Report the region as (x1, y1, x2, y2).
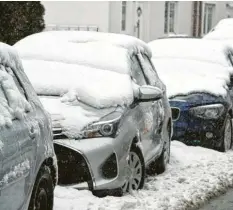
(219, 114, 232, 152)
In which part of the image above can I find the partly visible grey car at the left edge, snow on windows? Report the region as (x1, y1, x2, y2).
(0, 43, 57, 210)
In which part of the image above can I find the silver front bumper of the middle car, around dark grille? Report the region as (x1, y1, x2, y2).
(54, 137, 127, 190)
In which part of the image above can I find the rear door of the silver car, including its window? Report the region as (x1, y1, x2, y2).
(138, 54, 165, 150)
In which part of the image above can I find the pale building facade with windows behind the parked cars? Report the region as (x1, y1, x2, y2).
(42, 1, 233, 41)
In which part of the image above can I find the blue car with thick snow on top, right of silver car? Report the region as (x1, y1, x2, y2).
(149, 38, 233, 151)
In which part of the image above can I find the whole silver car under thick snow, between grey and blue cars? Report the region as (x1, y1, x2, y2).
(15, 31, 172, 195)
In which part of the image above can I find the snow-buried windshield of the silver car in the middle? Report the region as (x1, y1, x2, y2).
(23, 60, 133, 108)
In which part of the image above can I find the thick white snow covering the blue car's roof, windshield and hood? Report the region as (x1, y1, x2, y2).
(149, 39, 233, 97)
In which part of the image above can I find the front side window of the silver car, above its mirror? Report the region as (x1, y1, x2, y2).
(131, 56, 147, 86)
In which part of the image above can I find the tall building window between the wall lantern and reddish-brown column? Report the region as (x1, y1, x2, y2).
(164, 1, 177, 33)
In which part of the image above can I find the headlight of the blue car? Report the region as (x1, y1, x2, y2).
(190, 104, 224, 119)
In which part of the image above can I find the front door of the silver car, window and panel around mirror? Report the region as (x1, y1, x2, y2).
(131, 55, 154, 162)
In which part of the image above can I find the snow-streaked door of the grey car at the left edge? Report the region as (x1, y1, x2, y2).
(0, 66, 35, 210)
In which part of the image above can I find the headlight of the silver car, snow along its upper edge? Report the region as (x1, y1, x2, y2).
(82, 111, 122, 138)
